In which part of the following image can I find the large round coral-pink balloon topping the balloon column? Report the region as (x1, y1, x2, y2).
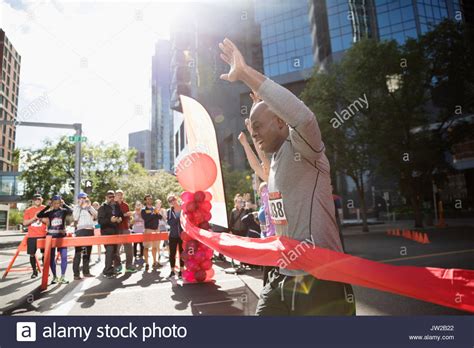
(176, 152, 217, 192)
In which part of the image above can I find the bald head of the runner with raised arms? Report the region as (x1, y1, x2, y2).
(250, 101, 288, 152)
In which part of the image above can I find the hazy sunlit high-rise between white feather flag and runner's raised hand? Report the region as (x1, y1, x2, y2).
(170, 0, 263, 169)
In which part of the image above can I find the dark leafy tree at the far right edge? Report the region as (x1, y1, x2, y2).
(373, 21, 473, 227)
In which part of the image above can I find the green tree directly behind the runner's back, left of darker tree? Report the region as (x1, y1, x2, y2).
(302, 39, 398, 231)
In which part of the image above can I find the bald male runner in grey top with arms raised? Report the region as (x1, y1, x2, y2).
(219, 39, 355, 315)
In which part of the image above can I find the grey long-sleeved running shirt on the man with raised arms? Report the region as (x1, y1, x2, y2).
(258, 79, 342, 275)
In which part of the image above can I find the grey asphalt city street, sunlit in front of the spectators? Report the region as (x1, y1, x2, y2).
(0, 220, 474, 315)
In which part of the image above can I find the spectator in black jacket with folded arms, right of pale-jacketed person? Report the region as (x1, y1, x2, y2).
(97, 190, 123, 278)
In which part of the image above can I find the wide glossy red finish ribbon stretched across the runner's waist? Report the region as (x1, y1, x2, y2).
(183, 218, 474, 312)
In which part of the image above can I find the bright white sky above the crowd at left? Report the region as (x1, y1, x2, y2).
(0, 0, 191, 149)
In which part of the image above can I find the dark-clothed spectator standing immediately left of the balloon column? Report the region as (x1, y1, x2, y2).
(166, 195, 184, 278)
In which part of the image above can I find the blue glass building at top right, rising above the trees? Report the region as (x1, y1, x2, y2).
(309, 0, 463, 65)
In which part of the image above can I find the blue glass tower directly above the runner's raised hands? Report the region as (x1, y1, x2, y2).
(255, 0, 314, 82)
